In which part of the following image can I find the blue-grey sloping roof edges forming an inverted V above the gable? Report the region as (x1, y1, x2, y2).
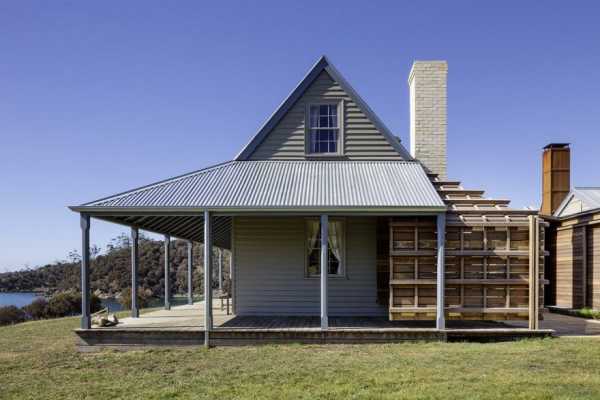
(235, 56, 413, 161)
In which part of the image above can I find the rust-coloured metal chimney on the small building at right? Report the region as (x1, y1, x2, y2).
(540, 143, 571, 215)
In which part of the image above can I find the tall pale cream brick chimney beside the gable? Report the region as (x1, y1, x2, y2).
(408, 61, 448, 179)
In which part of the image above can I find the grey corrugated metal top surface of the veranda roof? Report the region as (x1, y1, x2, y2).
(72, 161, 445, 211)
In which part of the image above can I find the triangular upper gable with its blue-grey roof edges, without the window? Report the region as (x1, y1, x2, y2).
(236, 57, 412, 160)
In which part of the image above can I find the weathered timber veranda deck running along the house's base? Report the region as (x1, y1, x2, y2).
(75, 302, 553, 351)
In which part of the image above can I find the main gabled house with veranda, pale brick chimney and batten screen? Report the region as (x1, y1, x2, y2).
(71, 57, 545, 343)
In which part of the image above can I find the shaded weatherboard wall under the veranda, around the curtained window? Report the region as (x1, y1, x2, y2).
(234, 217, 387, 316)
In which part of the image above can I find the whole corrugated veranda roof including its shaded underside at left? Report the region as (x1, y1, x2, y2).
(70, 161, 446, 248)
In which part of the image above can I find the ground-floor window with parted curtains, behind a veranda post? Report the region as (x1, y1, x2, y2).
(306, 219, 344, 277)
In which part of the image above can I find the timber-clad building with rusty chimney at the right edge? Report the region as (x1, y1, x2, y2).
(541, 143, 600, 310)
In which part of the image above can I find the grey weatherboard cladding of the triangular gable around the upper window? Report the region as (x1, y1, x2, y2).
(250, 71, 402, 160)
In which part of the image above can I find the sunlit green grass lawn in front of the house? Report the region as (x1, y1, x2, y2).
(0, 318, 600, 399)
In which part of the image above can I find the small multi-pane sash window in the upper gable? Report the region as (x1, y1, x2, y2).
(307, 103, 341, 154)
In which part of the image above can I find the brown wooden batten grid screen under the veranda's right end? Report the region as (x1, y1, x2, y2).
(389, 218, 543, 320)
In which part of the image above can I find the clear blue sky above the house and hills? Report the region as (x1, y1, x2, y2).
(0, 0, 600, 271)
